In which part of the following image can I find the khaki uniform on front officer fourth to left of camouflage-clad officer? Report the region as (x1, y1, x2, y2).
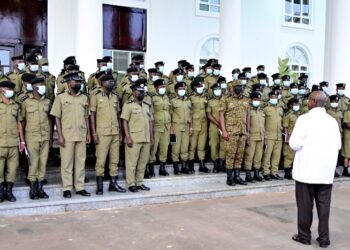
(150, 95, 171, 163)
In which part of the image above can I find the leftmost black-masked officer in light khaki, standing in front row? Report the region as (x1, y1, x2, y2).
(51, 73, 91, 198)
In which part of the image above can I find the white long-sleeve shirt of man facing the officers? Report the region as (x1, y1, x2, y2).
(289, 108, 341, 184)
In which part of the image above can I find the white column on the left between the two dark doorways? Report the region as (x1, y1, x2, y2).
(74, 0, 103, 77)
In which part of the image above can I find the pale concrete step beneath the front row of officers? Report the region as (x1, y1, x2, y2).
(0, 172, 350, 216)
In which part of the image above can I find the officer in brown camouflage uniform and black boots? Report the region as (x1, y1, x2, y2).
(219, 84, 250, 186)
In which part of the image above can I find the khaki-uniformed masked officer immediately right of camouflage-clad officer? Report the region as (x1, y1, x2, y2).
(244, 92, 265, 182)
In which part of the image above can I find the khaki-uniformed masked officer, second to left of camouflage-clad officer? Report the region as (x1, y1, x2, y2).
(189, 77, 210, 173)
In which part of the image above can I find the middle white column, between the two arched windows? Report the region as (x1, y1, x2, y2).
(219, 0, 241, 78)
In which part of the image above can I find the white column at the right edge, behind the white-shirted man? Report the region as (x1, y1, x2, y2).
(324, 0, 350, 96)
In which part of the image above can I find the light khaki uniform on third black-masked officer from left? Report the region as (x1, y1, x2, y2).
(120, 101, 153, 187)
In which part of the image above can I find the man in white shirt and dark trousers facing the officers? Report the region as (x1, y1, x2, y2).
(289, 91, 341, 247)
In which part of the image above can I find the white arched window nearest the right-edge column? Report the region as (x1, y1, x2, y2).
(286, 46, 310, 76)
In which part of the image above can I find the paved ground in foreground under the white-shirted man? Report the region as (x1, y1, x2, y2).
(0, 187, 350, 250)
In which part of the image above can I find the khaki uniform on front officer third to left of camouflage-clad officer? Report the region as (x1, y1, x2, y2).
(170, 97, 191, 162)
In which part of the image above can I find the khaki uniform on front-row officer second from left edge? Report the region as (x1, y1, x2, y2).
(21, 94, 50, 182)
